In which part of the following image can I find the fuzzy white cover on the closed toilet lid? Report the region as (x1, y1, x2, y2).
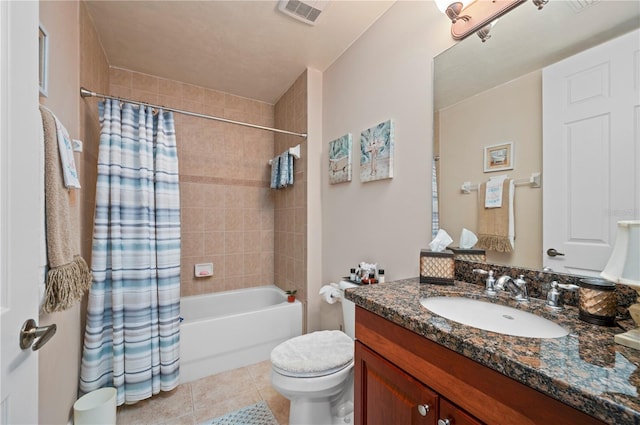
(271, 331, 353, 376)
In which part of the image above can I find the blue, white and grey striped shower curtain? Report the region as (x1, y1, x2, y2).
(80, 100, 180, 405)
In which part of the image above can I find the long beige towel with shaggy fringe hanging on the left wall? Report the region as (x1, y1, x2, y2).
(40, 106, 91, 313)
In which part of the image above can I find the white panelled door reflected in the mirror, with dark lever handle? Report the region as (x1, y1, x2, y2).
(542, 30, 640, 276)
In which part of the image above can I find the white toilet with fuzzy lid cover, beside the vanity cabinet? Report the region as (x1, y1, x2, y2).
(271, 281, 358, 425)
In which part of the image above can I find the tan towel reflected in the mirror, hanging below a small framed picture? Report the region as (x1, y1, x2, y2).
(476, 179, 513, 252)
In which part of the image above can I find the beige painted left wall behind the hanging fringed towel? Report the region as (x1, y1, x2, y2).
(38, 1, 81, 424)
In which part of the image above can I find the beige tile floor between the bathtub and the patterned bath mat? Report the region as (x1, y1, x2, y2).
(117, 360, 289, 425)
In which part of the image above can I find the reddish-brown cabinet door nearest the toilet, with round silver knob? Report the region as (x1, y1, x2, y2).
(355, 341, 438, 425)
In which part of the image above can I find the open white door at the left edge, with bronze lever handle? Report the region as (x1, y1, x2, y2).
(0, 0, 43, 424)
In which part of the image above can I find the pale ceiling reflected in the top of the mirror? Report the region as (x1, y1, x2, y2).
(434, 0, 640, 110)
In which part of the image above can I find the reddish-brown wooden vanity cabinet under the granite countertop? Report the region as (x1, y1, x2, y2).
(354, 306, 604, 425)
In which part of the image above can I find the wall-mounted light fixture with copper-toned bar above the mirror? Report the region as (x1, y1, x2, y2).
(435, 0, 549, 42)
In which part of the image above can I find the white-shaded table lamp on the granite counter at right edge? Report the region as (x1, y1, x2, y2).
(600, 220, 640, 349)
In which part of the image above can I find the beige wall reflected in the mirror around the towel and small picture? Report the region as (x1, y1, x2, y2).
(439, 71, 542, 269)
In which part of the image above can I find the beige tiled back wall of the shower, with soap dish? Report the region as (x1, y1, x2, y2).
(109, 68, 274, 296)
